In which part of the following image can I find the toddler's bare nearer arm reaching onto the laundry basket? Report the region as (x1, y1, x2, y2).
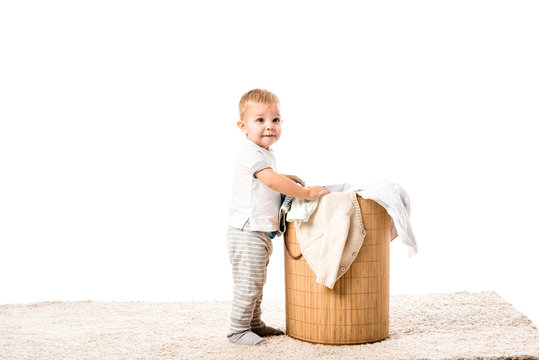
(255, 168, 330, 200)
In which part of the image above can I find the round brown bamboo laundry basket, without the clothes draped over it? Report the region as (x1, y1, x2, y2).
(284, 196, 391, 344)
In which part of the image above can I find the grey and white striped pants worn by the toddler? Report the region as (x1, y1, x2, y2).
(227, 223, 273, 336)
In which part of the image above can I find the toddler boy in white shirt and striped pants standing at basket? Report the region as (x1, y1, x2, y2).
(227, 89, 329, 345)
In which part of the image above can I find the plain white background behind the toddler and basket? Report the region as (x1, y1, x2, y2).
(0, 1, 539, 325)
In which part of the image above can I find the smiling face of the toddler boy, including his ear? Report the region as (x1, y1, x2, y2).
(237, 104, 282, 150)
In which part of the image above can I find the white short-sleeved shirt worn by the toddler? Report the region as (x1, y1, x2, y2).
(229, 138, 281, 232)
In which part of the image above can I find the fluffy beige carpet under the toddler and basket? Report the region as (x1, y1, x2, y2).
(0, 292, 539, 360)
